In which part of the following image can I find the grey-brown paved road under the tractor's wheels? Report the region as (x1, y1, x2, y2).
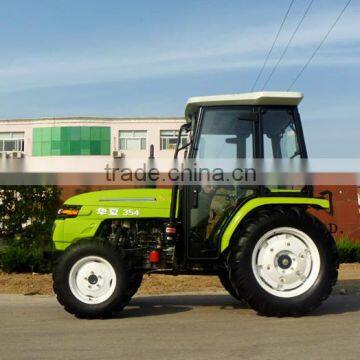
(0, 294, 360, 360)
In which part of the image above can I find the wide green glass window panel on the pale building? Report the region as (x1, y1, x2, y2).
(33, 126, 110, 156)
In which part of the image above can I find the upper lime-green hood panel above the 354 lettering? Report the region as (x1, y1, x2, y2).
(65, 188, 171, 209)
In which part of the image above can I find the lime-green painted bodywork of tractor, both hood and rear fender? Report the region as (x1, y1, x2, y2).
(53, 188, 330, 252)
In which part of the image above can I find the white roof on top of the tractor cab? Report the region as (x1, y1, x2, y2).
(185, 91, 304, 119)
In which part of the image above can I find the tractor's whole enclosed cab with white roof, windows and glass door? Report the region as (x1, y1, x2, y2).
(172, 92, 307, 260)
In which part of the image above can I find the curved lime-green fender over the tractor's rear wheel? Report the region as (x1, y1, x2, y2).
(220, 197, 330, 253)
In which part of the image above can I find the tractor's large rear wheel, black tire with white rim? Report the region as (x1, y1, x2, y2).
(229, 208, 339, 316)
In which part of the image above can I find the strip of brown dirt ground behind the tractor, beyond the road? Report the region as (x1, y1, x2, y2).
(0, 263, 360, 295)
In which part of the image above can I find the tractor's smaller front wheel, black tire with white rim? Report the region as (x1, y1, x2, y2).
(53, 239, 130, 318)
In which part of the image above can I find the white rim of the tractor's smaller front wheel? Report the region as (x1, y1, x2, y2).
(69, 256, 116, 304)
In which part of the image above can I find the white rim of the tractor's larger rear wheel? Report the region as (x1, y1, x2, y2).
(251, 227, 321, 298)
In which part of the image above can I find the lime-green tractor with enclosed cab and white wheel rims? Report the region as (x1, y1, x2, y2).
(53, 92, 339, 318)
